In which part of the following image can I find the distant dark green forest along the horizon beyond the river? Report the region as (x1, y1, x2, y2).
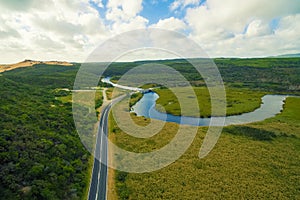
(104, 58, 300, 93)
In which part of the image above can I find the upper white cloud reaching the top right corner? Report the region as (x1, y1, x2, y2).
(186, 0, 300, 36)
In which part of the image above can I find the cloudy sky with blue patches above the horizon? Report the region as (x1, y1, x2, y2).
(0, 0, 300, 63)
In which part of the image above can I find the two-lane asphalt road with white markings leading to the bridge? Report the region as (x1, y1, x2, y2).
(88, 95, 126, 200)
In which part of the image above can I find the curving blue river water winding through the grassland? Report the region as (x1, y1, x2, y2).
(132, 92, 288, 126)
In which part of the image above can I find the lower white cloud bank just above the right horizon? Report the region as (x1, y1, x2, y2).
(193, 14, 300, 57)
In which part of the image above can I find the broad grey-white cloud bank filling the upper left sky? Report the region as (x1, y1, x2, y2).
(0, 0, 109, 63)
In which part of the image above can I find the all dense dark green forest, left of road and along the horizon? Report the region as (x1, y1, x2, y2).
(0, 58, 300, 199)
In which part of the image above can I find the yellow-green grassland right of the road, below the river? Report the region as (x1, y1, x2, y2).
(110, 98, 300, 199)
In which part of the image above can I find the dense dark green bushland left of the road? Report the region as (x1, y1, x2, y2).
(0, 65, 99, 199)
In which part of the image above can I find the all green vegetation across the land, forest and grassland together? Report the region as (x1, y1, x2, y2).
(0, 58, 300, 199)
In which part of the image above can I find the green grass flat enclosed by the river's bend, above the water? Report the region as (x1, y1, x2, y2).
(156, 87, 266, 117)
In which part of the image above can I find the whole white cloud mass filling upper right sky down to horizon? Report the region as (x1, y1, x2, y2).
(185, 0, 300, 57)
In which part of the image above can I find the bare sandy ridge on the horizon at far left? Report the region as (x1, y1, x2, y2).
(0, 60, 73, 73)
